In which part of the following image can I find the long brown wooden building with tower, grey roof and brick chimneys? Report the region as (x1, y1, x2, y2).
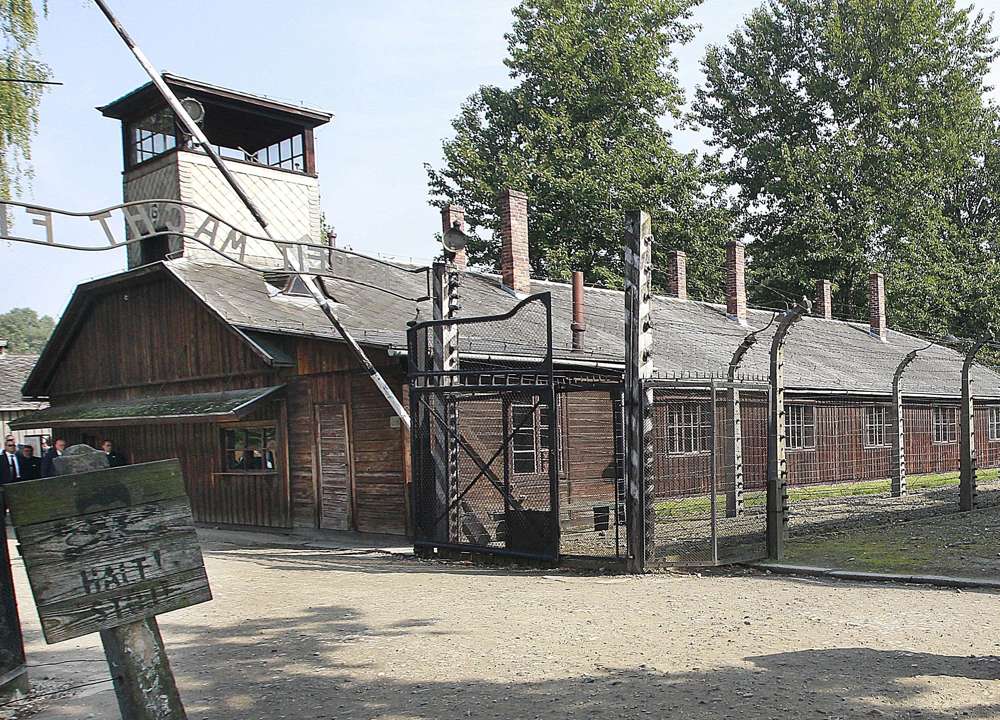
(15, 76, 1000, 534)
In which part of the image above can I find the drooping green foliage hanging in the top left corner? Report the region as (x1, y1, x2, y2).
(0, 0, 49, 198)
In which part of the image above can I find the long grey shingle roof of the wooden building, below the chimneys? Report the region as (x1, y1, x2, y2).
(158, 250, 1000, 398)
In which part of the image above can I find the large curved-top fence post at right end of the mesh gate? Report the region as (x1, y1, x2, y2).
(767, 303, 809, 560)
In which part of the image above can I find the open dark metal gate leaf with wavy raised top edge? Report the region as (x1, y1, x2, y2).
(408, 293, 559, 561)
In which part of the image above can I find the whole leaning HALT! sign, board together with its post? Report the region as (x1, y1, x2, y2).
(7, 445, 212, 720)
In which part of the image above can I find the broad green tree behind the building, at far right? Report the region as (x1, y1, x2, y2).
(694, 0, 996, 330)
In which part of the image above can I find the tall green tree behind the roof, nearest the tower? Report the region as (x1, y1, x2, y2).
(426, 0, 729, 297)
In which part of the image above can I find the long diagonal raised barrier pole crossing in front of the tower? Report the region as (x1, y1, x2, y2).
(95, 0, 410, 430)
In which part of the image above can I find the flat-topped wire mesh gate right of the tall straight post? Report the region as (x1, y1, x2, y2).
(646, 379, 770, 566)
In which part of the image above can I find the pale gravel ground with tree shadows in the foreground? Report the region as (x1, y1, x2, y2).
(0, 538, 1000, 720)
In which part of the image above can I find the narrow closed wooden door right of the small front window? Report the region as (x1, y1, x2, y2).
(315, 403, 354, 530)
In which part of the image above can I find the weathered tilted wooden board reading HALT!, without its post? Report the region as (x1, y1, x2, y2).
(6, 460, 212, 643)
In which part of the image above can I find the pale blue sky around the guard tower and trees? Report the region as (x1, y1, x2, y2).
(0, 0, 1000, 316)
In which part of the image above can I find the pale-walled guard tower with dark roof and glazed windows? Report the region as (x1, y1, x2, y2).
(98, 73, 333, 269)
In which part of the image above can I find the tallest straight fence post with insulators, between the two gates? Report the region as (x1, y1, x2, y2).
(625, 210, 656, 572)
